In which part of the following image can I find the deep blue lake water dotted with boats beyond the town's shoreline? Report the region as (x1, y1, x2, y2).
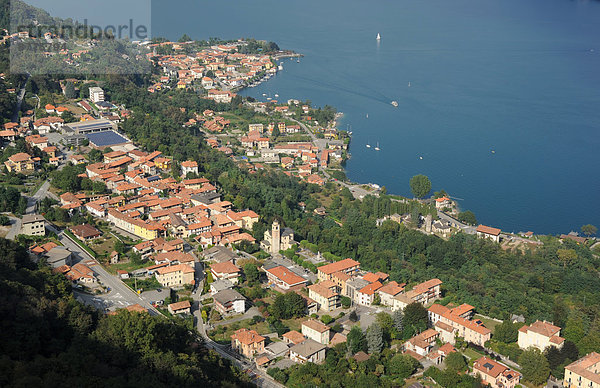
(42, 0, 600, 233)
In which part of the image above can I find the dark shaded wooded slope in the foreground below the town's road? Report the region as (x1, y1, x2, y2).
(0, 239, 251, 387)
